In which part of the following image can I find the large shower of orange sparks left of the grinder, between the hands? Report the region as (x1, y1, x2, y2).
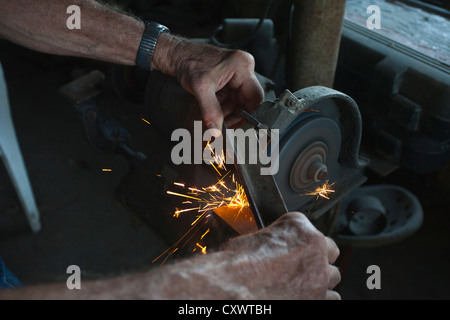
(153, 143, 252, 265)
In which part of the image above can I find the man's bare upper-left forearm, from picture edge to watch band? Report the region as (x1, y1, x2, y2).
(0, 0, 144, 65)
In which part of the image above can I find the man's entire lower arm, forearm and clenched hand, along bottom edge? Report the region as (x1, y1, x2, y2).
(0, 213, 340, 299)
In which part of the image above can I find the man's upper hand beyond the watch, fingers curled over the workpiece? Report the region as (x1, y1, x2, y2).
(152, 33, 264, 130)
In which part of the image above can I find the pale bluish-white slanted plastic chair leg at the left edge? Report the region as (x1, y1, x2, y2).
(0, 63, 41, 232)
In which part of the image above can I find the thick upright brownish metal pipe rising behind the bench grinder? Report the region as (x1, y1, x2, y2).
(288, 0, 346, 91)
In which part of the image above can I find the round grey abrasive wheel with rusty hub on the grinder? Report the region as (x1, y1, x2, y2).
(275, 112, 341, 211)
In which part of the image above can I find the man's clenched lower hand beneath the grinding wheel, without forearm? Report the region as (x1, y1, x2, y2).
(221, 213, 341, 299)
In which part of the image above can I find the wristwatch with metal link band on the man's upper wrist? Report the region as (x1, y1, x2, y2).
(136, 21, 170, 71)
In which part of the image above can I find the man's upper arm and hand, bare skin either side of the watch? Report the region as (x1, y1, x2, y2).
(0, 0, 264, 130)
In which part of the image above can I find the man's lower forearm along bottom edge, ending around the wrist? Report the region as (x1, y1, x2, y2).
(0, 252, 248, 300)
